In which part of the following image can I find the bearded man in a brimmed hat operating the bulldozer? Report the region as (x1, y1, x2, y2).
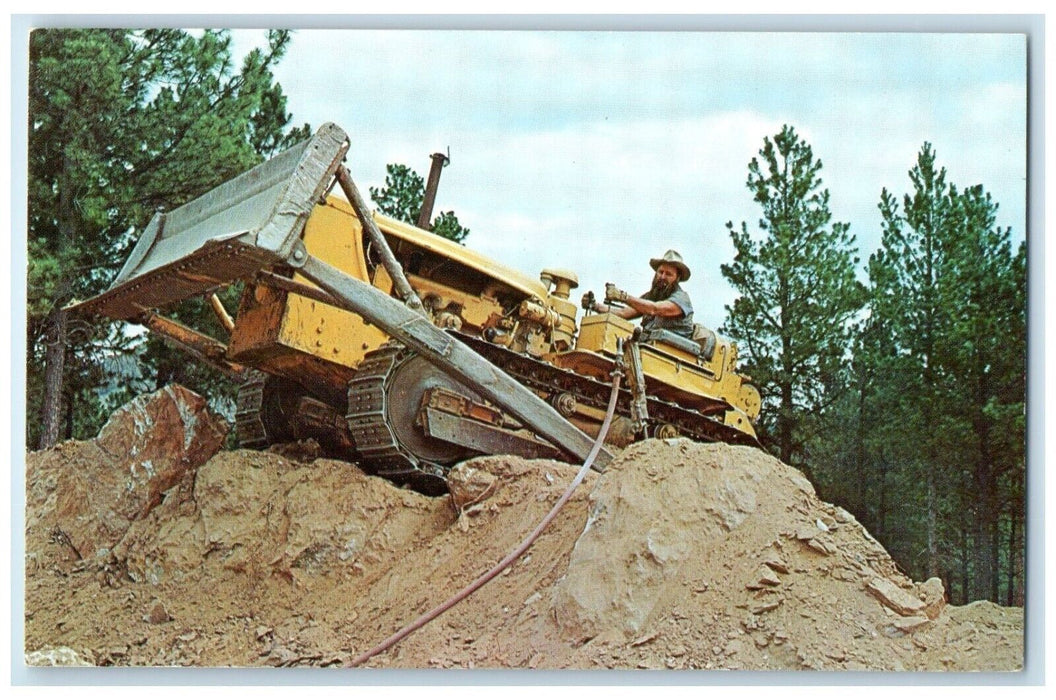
(583, 250, 693, 338)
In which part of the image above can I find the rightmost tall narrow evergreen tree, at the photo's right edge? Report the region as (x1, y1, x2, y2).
(941, 185, 1026, 601)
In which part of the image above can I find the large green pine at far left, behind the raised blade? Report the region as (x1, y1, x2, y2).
(26, 29, 308, 447)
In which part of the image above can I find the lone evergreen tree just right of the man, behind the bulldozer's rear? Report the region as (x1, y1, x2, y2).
(721, 126, 862, 463)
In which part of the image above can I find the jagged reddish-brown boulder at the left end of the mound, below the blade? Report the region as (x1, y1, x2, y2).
(26, 384, 229, 559)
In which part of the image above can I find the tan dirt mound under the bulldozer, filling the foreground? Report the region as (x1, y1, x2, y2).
(25, 386, 1023, 670)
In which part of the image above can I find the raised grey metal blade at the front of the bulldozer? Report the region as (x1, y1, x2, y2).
(69, 124, 348, 320)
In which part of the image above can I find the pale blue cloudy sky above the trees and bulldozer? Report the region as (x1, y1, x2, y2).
(233, 30, 1027, 328)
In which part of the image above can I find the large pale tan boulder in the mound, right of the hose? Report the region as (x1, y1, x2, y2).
(552, 439, 765, 639)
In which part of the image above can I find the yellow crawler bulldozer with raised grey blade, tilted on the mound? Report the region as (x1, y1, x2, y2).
(70, 124, 760, 494)
